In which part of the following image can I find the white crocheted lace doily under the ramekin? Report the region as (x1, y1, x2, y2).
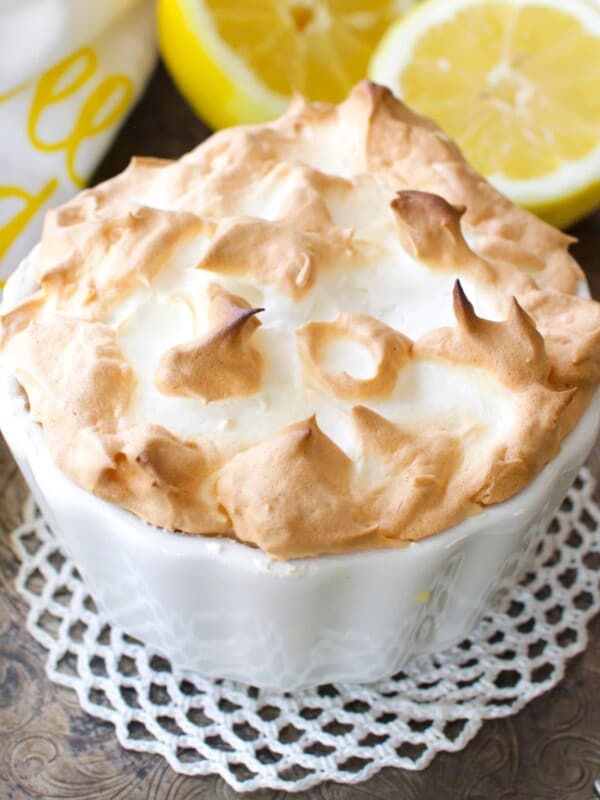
(8, 470, 600, 791)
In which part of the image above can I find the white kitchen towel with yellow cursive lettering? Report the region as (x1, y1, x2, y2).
(0, 0, 156, 285)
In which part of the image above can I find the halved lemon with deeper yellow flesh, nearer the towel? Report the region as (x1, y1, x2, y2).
(158, 0, 414, 128)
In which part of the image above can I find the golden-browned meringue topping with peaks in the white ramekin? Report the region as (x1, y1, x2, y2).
(0, 82, 600, 559)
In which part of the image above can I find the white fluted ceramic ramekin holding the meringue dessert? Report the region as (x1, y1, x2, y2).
(0, 253, 600, 690)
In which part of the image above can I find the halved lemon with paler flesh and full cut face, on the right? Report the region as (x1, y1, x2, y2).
(369, 0, 600, 227)
